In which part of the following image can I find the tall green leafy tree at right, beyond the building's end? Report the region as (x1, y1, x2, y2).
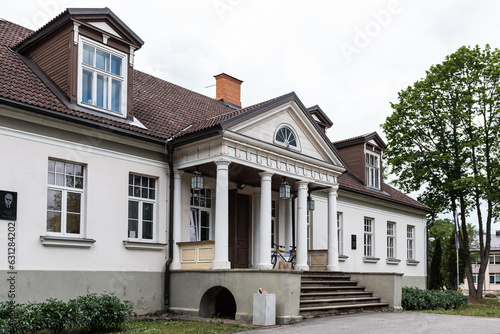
(382, 45, 500, 298)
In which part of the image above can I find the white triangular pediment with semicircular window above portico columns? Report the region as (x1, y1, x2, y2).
(226, 96, 343, 167)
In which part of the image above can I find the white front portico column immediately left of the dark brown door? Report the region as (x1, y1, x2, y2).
(213, 159, 231, 269)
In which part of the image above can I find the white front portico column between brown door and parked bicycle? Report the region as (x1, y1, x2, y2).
(257, 172, 273, 269)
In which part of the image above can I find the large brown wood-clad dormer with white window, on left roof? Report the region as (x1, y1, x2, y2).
(15, 8, 144, 120)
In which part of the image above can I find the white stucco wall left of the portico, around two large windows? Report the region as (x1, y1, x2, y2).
(0, 113, 168, 272)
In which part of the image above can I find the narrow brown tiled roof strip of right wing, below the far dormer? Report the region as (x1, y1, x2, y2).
(338, 172, 431, 212)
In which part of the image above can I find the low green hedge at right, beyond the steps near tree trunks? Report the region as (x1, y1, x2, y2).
(401, 288, 467, 310)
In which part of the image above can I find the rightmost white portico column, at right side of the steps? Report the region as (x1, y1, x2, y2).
(326, 185, 340, 271)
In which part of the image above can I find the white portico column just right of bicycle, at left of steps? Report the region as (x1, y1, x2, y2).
(295, 181, 309, 270)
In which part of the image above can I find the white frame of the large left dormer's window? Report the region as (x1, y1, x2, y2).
(77, 36, 128, 118)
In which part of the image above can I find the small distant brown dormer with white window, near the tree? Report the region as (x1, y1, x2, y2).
(333, 132, 387, 190)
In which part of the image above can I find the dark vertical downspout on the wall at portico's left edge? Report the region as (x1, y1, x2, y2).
(164, 141, 174, 309)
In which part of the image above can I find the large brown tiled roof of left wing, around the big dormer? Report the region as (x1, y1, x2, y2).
(0, 21, 242, 140)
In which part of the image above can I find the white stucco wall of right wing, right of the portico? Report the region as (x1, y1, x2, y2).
(312, 191, 426, 281)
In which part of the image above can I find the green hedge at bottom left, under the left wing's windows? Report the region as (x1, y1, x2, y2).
(0, 293, 133, 334)
